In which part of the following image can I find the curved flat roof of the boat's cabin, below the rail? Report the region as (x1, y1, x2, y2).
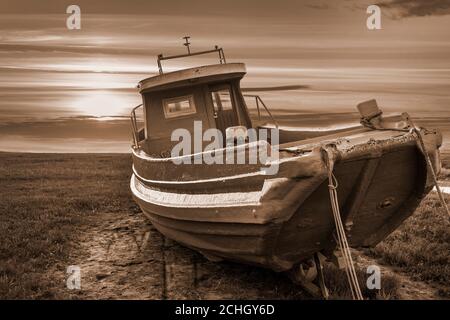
(138, 63, 246, 93)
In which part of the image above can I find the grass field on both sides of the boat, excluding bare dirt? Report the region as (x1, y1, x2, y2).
(0, 153, 450, 299)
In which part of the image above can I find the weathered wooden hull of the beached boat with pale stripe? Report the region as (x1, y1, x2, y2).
(130, 129, 440, 271)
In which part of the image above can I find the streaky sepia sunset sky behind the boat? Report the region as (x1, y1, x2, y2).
(0, 0, 450, 152)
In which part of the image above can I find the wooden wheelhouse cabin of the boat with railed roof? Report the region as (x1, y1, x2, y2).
(132, 47, 252, 157)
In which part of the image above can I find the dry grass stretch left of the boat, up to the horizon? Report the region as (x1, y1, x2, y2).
(0, 153, 137, 299)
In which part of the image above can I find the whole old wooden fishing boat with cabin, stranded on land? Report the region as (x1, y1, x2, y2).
(130, 42, 442, 298)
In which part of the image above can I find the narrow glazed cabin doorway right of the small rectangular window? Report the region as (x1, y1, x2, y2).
(209, 84, 239, 137)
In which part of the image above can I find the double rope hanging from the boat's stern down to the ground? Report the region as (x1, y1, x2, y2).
(324, 148, 364, 300)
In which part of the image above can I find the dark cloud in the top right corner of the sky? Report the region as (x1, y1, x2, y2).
(377, 0, 450, 18)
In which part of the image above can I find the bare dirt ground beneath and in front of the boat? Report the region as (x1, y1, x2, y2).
(61, 213, 439, 299)
